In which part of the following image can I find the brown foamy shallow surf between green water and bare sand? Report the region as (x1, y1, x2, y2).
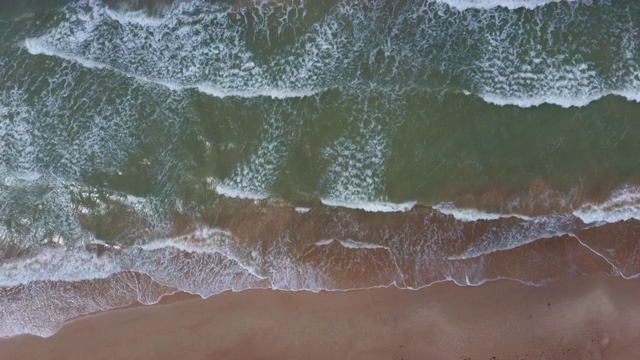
(0, 187, 640, 336)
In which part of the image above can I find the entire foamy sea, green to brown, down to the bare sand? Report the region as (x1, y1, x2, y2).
(0, 0, 640, 336)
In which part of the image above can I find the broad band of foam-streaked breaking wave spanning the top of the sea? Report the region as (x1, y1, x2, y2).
(25, 0, 640, 107)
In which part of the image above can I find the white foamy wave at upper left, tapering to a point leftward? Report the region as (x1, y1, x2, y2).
(24, 0, 331, 99)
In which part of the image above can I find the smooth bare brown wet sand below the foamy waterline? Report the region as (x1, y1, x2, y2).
(0, 275, 640, 360)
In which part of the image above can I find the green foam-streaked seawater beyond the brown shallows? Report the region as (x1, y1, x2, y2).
(0, 1, 640, 242)
